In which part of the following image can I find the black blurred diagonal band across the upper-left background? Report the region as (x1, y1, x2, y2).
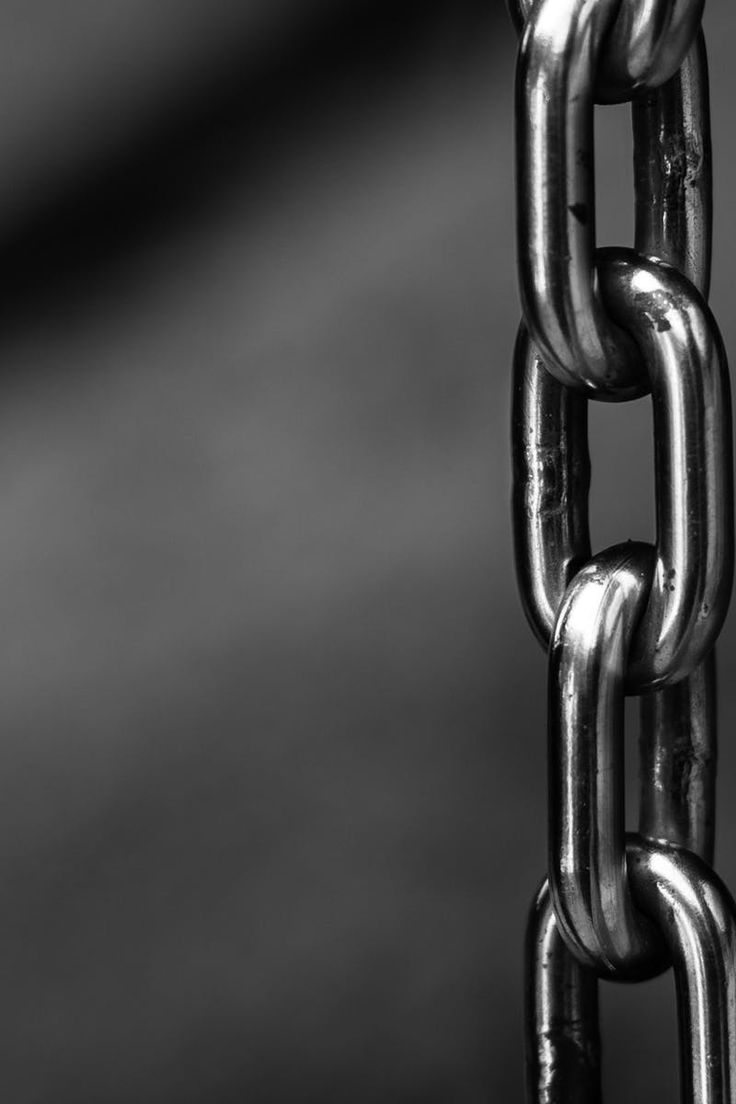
(0, 0, 500, 341)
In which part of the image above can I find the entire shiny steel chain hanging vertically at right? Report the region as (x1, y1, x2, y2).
(510, 0, 736, 1104)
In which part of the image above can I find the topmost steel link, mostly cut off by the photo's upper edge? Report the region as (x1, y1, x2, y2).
(509, 0, 703, 104)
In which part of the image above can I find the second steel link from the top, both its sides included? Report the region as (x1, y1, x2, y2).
(516, 0, 711, 401)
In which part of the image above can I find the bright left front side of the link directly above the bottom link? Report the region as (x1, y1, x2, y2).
(548, 542, 665, 977)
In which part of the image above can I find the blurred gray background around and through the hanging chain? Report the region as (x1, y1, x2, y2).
(0, 0, 736, 1104)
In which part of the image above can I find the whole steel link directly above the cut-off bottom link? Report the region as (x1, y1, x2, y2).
(548, 542, 715, 978)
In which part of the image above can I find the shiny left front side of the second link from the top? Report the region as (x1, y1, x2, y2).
(516, 0, 647, 400)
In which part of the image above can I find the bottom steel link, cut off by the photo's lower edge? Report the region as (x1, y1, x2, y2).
(526, 837, 736, 1104)
